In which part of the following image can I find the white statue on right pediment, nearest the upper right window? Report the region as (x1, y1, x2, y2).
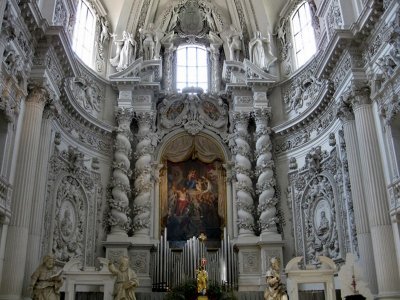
(249, 31, 277, 71)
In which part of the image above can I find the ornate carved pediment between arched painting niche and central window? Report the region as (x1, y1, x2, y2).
(158, 94, 228, 136)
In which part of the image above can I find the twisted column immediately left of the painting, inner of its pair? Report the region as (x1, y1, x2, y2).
(132, 112, 155, 237)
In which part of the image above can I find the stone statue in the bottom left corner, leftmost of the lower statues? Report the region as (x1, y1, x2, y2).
(29, 255, 63, 300)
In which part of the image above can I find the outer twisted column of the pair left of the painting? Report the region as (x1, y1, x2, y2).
(108, 108, 133, 235)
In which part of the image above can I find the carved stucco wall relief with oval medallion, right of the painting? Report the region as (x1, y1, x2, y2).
(288, 147, 353, 264)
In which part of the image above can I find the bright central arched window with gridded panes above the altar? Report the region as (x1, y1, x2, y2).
(176, 46, 208, 92)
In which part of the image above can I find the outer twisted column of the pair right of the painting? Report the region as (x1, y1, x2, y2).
(254, 108, 278, 235)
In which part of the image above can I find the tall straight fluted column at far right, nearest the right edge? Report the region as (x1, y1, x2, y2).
(353, 87, 400, 299)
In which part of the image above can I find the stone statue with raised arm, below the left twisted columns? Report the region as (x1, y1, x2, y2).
(108, 256, 139, 300)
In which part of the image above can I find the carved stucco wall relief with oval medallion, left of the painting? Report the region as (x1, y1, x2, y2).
(42, 147, 104, 266)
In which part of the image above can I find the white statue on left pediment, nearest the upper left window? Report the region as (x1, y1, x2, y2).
(110, 30, 137, 72)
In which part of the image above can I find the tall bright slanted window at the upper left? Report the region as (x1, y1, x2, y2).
(72, 1, 96, 66)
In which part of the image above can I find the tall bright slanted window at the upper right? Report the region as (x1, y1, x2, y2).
(291, 2, 317, 68)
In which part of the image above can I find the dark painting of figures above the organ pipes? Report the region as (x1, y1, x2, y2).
(167, 160, 221, 245)
